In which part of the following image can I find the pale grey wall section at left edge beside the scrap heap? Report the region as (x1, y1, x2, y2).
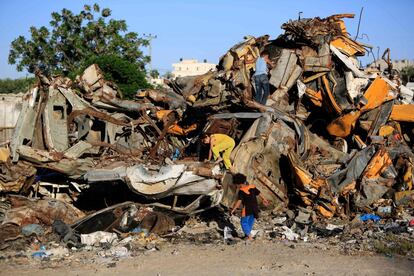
(0, 94, 23, 143)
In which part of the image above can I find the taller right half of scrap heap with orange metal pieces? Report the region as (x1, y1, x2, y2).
(163, 14, 414, 218)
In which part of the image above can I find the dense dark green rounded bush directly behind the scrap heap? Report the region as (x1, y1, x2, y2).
(75, 55, 151, 99)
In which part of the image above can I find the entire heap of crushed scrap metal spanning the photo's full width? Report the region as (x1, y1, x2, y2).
(0, 14, 414, 230)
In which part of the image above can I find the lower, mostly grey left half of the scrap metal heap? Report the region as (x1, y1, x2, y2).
(0, 65, 226, 213)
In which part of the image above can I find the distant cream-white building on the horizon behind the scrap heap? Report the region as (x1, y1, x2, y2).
(171, 59, 216, 78)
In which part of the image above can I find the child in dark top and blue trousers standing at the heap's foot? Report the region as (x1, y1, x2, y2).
(230, 173, 269, 240)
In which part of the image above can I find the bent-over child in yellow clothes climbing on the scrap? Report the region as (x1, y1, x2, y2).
(202, 133, 236, 171)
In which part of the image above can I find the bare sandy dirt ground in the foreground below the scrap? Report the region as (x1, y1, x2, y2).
(0, 241, 414, 276)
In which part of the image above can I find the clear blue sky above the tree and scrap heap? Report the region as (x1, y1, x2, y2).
(0, 0, 414, 78)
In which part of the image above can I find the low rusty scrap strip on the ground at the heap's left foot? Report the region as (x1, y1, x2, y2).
(0, 195, 175, 250)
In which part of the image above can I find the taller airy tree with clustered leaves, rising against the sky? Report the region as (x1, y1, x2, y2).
(9, 4, 149, 76)
